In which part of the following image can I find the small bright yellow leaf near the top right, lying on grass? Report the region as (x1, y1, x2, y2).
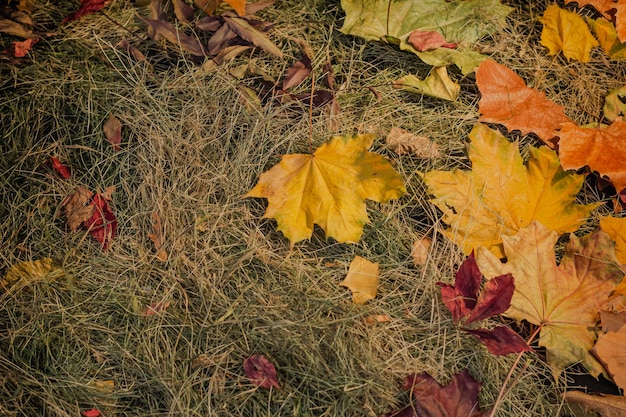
(539, 4, 598, 62)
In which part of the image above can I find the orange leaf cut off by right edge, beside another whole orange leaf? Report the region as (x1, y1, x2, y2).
(559, 119, 626, 193)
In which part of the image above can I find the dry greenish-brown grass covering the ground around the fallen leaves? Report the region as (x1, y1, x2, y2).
(0, 0, 626, 416)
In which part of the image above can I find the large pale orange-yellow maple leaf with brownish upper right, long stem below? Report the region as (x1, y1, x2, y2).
(477, 222, 624, 377)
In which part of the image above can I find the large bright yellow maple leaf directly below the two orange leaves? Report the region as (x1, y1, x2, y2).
(423, 124, 597, 257)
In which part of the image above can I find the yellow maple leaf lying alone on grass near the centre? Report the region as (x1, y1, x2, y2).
(244, 134, 406, 246)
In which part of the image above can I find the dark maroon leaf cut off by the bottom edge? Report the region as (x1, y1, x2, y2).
(383, 371, 489, 417)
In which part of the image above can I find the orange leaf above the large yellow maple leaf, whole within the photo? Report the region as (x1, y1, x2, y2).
(476, 59, 571, 146)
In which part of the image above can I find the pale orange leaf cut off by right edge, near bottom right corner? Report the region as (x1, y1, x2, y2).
(592, 310, 626, 388)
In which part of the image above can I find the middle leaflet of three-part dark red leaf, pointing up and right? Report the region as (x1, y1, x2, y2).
(465, 274, 515, 324)
